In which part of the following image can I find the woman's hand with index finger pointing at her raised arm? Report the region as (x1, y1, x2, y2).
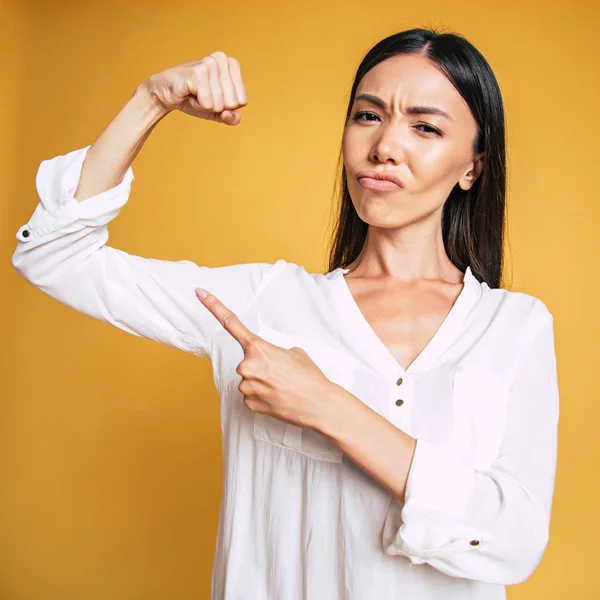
(196, 288, 338, 430)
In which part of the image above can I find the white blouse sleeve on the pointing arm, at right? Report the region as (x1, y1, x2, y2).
(385, 308, 559, 585)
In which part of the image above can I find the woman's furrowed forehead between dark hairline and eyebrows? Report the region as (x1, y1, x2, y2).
(356, 54, 472, 121)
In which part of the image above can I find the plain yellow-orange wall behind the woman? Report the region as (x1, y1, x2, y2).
(0, 0, 600, 600)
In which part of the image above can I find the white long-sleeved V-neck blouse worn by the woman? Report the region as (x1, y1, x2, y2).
(12, 146, 559, 600)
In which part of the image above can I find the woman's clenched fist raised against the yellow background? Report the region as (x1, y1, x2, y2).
(138, 51, 248, 125)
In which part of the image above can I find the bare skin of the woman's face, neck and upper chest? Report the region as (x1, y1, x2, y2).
(342, 54, 483, 369)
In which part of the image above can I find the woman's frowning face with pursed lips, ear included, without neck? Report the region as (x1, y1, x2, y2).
(342, 54, 482, 227)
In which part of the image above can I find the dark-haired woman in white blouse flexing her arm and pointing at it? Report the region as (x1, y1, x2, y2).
(13, 29, 559, 600)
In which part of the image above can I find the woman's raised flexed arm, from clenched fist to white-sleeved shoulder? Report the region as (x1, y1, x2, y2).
(12, 52, 270, 358)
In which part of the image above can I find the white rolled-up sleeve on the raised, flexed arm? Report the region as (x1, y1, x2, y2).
(12, 146, 272, 358)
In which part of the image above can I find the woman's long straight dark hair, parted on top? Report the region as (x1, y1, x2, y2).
(329, 29, 506, 288)
